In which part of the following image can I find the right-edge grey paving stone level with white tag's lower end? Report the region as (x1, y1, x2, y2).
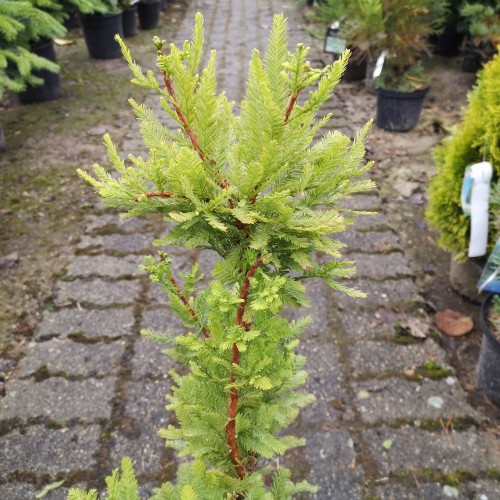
(334, 228, 402, 254)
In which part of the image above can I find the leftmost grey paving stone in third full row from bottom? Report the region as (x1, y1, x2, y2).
(18, 338, 125, 378)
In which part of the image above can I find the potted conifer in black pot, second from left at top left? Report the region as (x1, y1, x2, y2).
(80, 0, 123, 59)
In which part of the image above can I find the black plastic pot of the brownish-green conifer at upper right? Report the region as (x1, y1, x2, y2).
(376, 88, 429, 132)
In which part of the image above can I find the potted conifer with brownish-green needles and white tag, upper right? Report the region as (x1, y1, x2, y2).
(376, 0, 447, 132)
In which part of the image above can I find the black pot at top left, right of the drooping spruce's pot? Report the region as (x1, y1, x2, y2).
(82, 12, 123, 59)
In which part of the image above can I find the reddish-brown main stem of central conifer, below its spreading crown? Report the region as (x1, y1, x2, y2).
(226, 257, 263, 479)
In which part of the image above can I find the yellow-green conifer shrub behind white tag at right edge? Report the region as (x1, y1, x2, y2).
(427, 49, 500, 260)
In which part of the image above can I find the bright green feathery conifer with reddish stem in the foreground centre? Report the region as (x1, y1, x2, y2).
(72, 14, 374, 500)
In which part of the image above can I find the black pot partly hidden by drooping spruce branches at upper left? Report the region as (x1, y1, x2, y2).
(19, 40, 63, 104)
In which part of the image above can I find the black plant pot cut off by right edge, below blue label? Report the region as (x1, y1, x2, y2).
(477, 294, 500, 406)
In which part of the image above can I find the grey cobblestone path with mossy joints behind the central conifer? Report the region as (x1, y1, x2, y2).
(0, 0, 500, 500)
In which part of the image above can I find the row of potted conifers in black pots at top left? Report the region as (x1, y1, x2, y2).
(0, 0, 167, 152)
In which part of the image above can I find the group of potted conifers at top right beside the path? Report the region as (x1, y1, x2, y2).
(313, 0, 500, 131)
